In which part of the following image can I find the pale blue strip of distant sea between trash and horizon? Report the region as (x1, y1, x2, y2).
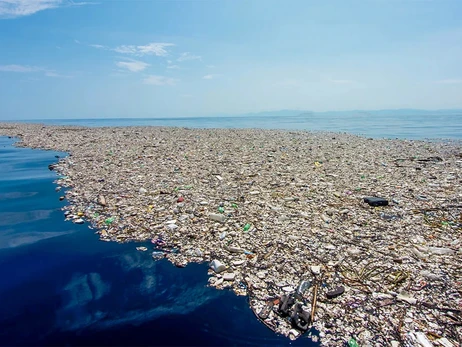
(13, 112, 462, 139)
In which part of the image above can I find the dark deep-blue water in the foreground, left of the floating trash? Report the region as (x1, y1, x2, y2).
(0, 137, 316, 346)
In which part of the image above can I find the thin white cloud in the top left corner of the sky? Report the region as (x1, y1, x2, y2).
(0, 0, 97, 19)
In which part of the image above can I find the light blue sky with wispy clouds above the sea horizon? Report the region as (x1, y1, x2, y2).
(0, 0, 462, 120)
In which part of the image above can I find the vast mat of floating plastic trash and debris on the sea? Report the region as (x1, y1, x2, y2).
(0, 123, 462, 347)
